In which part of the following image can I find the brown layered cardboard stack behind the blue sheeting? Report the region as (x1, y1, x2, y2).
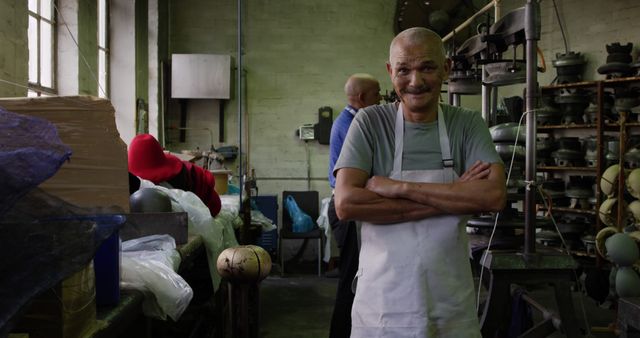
(0, 96, 129, 212)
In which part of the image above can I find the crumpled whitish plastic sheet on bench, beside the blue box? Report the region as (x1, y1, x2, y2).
(120, 235, 193, 321)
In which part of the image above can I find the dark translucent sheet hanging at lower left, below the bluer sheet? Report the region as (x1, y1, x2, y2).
(0, 189, 124, 336)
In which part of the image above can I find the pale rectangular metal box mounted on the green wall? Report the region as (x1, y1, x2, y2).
(171, 54, 231, 99)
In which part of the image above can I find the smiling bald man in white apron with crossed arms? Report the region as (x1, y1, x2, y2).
(334, 28, 506, 338)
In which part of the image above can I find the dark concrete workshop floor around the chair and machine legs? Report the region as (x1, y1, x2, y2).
(260, 268, 616, 338)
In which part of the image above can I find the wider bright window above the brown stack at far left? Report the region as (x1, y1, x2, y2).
(27, 0, 56, 96)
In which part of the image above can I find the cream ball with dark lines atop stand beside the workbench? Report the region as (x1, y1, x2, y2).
(217, 245, 271, 282)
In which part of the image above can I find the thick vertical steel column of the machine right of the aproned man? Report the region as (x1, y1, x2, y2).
(524, 0, 540, 258)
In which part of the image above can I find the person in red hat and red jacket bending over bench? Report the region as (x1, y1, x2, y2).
(128, 134, 221, 217)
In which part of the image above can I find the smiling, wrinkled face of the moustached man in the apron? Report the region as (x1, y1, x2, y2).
(387, 41, 450, 114)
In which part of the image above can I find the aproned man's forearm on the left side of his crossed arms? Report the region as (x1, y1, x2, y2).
(335, 188, 442, 224)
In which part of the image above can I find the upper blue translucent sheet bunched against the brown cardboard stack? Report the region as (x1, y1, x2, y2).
(0, 107, 71, 216)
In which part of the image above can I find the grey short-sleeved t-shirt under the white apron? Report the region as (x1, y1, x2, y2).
(333, 103, 502, 176)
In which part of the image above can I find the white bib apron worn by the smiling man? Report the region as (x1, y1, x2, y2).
(351, 105, 481, 338)
